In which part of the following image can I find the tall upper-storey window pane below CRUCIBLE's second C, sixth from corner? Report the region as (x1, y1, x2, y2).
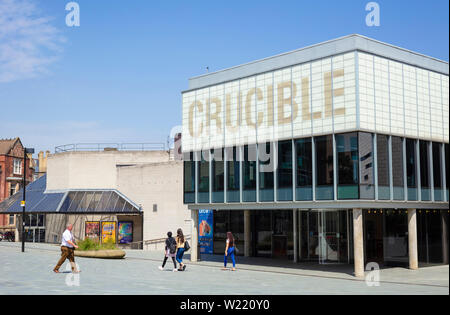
(242, 145, 257, 202)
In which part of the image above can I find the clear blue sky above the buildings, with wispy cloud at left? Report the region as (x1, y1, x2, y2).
(0, 0, 449, 156)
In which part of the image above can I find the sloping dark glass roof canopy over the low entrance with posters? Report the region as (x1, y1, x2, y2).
(0, 175, 141, 214)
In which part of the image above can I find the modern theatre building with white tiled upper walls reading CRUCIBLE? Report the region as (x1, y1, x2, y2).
(182, 35, 449, 276)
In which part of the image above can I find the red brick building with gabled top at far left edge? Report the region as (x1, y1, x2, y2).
(0, 138, 34, 233)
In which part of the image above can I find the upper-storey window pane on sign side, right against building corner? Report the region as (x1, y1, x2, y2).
(336, 133, 359, 199)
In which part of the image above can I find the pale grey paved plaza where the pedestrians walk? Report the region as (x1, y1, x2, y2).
(0, 242, 449, 295)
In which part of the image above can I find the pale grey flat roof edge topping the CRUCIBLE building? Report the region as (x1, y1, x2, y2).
(183, 34, 449, 93)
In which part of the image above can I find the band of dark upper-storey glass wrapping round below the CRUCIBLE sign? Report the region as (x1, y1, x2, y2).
(181, 132, 449, 205)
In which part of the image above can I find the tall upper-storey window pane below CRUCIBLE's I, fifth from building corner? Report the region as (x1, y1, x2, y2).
(259, 143, 275, 202)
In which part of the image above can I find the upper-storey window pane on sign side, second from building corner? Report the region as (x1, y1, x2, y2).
(315, 135, 334, 200)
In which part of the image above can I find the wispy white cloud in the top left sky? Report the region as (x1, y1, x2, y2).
(0, 0, 65, 83)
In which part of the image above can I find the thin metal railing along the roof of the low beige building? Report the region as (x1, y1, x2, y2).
(55, 143, 166, 154)
